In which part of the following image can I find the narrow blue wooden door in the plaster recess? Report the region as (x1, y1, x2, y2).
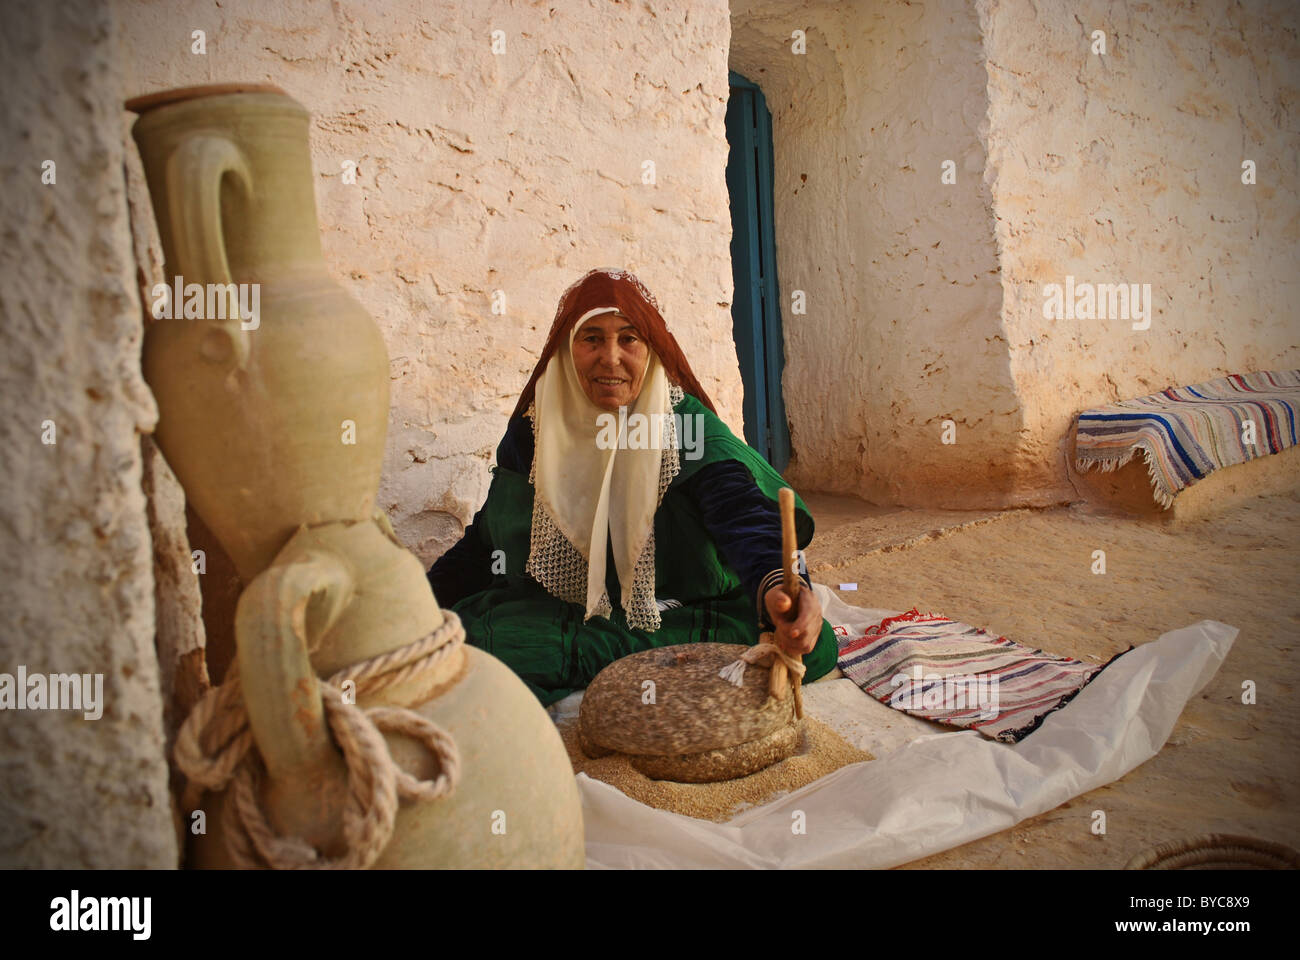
(727, 72, 790, 471)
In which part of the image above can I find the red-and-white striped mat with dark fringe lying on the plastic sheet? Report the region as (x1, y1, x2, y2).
(836, 609, 1104, 743)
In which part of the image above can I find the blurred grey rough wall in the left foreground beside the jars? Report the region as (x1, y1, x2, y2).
(0, 0, 177, 868)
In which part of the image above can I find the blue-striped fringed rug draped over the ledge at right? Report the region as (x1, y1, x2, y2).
(1075, 369, 1300, 510)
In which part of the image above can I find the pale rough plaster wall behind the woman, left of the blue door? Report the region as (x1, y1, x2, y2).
(118, 0, 741, 563)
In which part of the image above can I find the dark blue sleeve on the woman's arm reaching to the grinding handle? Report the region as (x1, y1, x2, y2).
(685, 460, 807, 626)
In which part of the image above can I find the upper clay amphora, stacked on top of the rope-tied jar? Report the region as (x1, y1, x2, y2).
(127, 87, 389, 574)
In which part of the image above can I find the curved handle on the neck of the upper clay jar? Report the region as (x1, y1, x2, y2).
(166, 131, 250, 368)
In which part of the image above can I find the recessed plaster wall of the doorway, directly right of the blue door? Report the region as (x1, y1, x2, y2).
(731, 0, 1035, 507)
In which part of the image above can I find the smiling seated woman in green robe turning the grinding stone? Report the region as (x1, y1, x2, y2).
(429, 271, 836, 704)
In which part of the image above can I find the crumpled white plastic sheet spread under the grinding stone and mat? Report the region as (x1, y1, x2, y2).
(574, 585, 1238, 868)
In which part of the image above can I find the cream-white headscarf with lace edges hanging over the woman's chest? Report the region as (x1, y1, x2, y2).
(528, 306, 681, 631)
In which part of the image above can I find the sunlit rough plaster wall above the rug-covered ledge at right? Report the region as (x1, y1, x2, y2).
(979, 0, 1300, 489)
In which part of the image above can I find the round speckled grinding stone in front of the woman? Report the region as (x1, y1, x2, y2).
(579, 644, 800, 783)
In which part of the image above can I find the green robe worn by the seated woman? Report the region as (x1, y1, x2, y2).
(452, 394, 837, 704)
